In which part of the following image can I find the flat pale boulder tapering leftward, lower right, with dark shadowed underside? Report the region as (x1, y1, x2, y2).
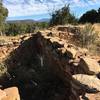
(73, 74, 100, 93)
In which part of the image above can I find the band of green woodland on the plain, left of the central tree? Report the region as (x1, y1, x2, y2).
(2, 22, 48, 36)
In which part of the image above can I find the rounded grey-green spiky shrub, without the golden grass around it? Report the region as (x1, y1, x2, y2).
(78, 24, 98, 48)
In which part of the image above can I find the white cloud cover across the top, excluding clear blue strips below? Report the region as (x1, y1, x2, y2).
(4, 0, 98, 17)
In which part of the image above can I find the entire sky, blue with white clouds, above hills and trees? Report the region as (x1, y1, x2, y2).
(3, 0, 100, 20)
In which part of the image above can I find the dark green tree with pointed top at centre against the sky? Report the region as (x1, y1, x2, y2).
(50, 5, 76, 26)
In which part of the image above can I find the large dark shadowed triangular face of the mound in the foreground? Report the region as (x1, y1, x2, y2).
(5, 32, 79, 100)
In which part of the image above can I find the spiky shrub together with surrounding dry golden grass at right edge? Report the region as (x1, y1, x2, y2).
(75, 24, 100, 55)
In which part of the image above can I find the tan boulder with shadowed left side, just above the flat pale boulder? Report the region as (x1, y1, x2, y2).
(79, 57, 100, 75)
